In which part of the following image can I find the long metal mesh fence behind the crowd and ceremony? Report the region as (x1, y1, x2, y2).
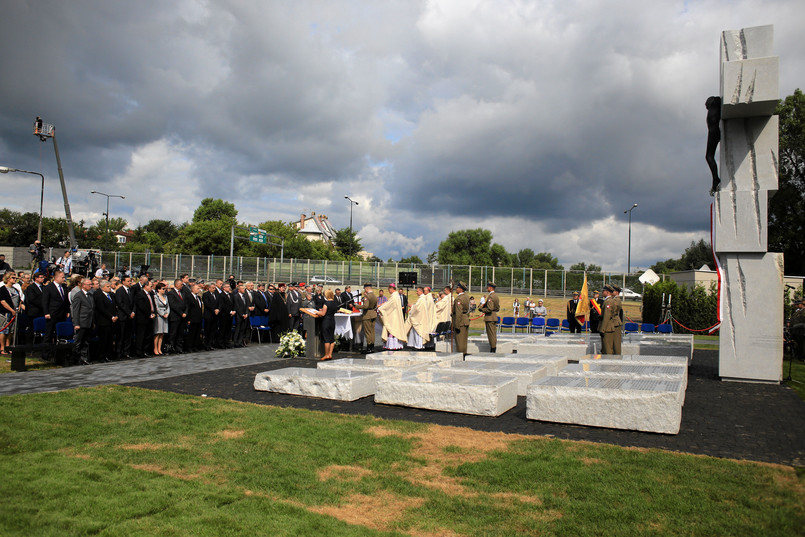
(70, 252, 652, 297)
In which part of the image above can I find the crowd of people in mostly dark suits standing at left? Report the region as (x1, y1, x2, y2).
(0, 269, 374, 364)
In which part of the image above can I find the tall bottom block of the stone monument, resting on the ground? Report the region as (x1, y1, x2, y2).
(718, 253, 783, 382)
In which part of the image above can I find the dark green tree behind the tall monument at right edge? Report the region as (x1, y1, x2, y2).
(769, 88, 805, 274)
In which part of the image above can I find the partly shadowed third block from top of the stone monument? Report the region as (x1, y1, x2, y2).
(719, 116, 780, 195)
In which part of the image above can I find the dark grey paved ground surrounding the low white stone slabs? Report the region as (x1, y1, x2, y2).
(129, 351, 805, 466)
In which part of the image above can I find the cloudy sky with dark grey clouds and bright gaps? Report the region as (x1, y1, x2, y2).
(0, 0, 805, 271)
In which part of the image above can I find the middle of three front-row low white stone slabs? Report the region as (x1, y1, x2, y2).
(375, 370, 517, 416)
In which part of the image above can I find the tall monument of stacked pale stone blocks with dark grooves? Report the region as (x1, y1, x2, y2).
(712, 25, 783, 382)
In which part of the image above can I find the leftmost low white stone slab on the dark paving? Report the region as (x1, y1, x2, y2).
(254, 367, 380, 401)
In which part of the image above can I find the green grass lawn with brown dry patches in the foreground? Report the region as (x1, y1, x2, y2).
(0, 387, 805, 537)
